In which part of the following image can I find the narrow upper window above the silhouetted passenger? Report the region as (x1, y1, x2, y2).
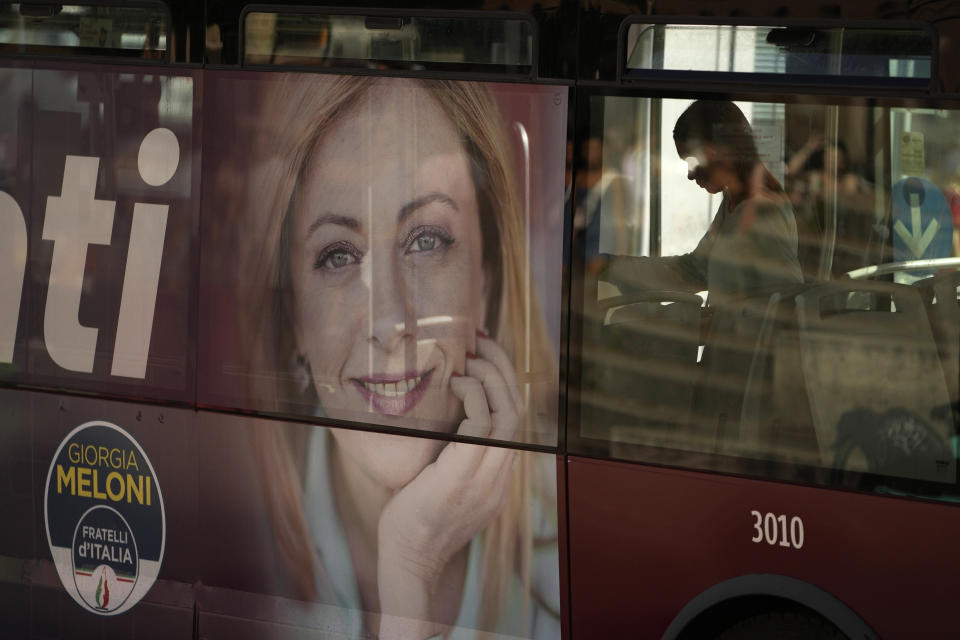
(626, 24, 933, 82)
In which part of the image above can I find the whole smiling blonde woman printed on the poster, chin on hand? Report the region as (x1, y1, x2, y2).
(240, 76, 559, 638)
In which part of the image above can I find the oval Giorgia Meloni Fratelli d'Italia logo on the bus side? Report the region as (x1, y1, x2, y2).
(44, 421, 166, 615)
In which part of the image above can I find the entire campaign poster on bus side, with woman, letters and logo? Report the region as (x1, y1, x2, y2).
(0, 57, 567, 639)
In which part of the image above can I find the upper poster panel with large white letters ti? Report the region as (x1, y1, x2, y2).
(0, 61, 200, 401)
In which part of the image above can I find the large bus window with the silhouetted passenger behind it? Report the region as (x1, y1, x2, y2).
(572, 96, 960, 492)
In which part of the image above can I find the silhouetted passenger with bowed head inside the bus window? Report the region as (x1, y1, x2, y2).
(598, 100, 803, 307)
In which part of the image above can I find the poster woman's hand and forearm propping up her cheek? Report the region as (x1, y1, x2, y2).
(377, 336, 523, 640)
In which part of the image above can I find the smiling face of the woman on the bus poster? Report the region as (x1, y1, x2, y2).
(289, 82, 486, 444)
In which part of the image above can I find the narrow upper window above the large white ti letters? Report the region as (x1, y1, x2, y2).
(0, 3, 169, 59)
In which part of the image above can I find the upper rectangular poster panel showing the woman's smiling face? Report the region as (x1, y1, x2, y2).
(198, 71, 567, 445)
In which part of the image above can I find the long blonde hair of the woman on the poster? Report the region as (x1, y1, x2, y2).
(233, 75, 557, 628)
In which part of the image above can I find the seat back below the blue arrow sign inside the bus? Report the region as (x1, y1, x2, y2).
(796, 281, 955, 481)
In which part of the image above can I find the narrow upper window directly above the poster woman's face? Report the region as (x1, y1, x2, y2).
(244, 11, 533, 73)
